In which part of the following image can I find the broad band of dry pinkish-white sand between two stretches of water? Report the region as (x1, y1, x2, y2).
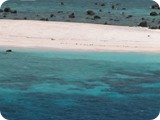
(0, 20, 160, 53)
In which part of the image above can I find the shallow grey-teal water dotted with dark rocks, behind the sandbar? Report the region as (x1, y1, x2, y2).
(0, 0, 160, 26)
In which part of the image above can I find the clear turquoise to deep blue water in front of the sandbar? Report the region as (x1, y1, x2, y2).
(0, 50, 160, 120)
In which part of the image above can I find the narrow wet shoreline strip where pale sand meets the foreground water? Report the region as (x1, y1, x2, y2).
(0, 45, 160, 54)
